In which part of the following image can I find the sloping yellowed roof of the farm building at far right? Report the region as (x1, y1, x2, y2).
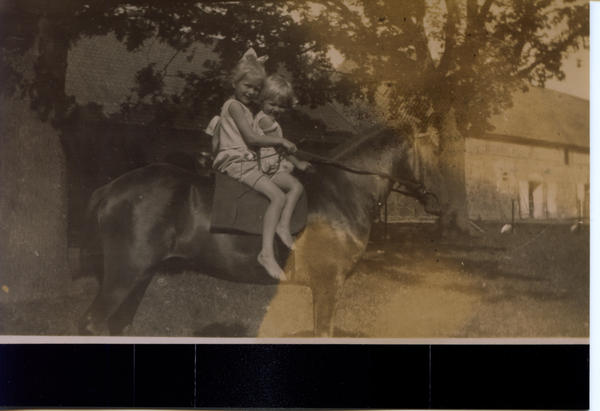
(482, 87, 590, 150)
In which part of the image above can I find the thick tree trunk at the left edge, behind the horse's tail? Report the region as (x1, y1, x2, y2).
(0, 17, 71, 301)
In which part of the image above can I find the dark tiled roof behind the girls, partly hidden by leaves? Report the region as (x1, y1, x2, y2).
(65, 34, 356, 143)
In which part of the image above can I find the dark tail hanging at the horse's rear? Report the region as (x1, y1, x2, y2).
(79, 184, 110, 277)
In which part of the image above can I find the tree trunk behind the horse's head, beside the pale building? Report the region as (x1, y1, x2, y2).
(438, 108, 472, 234)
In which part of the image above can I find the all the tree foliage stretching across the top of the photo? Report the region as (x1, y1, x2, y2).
(0, 0, 589, 132)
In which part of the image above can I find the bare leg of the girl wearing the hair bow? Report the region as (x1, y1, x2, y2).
(254, 177, 287, 281)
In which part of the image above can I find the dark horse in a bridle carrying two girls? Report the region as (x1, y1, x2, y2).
(79, 130, 437, 336)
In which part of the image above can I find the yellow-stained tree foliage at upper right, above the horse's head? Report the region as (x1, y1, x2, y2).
(299, 0, 589, 133)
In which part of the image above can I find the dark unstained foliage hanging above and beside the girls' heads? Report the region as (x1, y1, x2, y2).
(85, 2, 344, 123)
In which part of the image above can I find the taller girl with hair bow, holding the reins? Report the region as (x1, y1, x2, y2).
(213, 49, 296, 280)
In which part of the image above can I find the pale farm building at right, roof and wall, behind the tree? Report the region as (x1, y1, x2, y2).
(326, 81, 590, 221)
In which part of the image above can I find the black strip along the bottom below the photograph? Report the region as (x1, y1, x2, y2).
(0, 344, 589, 409)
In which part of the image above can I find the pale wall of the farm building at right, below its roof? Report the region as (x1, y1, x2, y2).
(466, 139, 590, 221)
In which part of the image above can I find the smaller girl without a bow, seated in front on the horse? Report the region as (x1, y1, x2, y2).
(253, 74, 310, 250)
